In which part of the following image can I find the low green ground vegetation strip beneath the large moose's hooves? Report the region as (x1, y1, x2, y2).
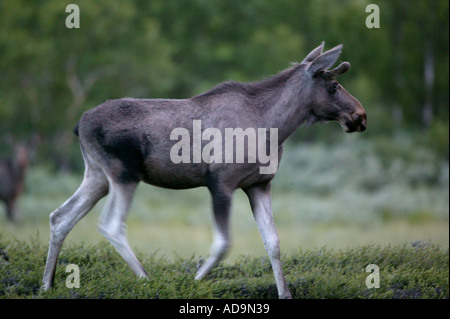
(0, 238, 449, 299)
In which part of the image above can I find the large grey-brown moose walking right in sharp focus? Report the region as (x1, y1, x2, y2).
(43, 42, 367, 298)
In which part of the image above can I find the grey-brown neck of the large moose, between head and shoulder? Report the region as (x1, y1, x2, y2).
(261, 65, 315, 145)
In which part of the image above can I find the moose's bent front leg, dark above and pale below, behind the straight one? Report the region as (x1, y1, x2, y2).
(195, 192, 231, 279)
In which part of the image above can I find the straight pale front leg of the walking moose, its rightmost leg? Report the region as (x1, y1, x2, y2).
(244, 183, 292, 299)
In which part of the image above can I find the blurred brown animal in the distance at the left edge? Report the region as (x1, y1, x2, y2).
(0, 136, 38, 223)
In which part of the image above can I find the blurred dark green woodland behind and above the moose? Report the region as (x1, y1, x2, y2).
(0, 0, 449, 170)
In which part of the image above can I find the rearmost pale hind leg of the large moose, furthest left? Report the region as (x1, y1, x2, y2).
(43, 167, 108, 290)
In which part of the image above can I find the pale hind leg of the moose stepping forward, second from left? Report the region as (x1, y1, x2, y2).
(98, 180, 147, 277)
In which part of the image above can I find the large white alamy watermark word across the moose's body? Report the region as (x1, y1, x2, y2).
(170, 120, 278, 174)
